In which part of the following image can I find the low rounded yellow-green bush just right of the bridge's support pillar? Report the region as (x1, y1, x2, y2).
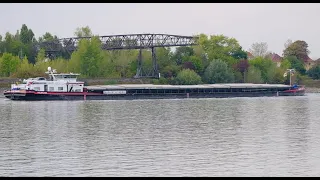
(175, 69, 201, 85)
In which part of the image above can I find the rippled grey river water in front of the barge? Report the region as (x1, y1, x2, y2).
(0, 94, 320, 176)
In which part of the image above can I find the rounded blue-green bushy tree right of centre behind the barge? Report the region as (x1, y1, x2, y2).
(204, 59, 234, 83)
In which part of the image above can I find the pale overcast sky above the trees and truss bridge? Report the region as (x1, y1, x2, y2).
(0, 3, 320, 60)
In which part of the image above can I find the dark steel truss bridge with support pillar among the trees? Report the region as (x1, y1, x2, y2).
(38, 34, 198, 78)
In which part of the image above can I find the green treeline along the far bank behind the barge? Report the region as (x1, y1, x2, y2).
(0, 25, 320, 84)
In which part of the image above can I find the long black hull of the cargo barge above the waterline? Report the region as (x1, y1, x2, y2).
(5, 92, 304, 101)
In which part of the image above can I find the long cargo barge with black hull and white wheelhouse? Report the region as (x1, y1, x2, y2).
(4, 67, 305, 101)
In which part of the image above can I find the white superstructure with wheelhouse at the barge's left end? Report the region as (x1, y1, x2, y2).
(11, 67, 84, 92)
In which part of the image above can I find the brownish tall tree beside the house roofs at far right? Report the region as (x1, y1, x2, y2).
(283, 40, 310, 61)
